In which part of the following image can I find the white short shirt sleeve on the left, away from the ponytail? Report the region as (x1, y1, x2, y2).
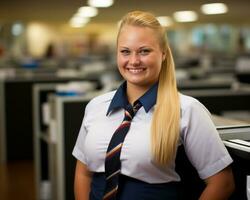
(72, 106, 87, 165)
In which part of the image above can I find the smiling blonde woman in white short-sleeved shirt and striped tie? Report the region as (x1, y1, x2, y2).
(73, 11, 234, 200)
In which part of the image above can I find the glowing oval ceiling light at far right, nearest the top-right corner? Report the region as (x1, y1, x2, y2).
(201, 3, 228, 15)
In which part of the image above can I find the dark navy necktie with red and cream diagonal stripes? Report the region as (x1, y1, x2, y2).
(103, 101, 142, 200)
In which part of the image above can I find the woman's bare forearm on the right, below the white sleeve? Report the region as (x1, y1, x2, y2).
(199, 167, 235, 200)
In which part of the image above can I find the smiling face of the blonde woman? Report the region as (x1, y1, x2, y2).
(117, 25, 165, 88)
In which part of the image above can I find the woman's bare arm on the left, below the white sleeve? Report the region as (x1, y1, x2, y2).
(74, 160, 92, 200)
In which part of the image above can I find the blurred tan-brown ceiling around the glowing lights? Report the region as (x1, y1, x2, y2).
(0, 0, 250, 24)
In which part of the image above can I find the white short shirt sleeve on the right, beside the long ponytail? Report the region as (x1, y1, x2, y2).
(182, 101, 232, 179)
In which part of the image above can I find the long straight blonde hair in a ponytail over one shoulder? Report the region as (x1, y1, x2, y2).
(117, 11, 180, 165)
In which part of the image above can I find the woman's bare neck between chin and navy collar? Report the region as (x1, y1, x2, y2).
(127, 82, 149, 105)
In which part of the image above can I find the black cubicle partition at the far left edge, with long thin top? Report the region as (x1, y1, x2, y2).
(0, 76, 100, 162)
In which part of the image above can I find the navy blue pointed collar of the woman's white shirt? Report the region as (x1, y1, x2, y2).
(107, 81, 158, 115)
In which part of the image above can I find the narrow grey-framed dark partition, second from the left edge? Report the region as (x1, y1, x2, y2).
(32, 83, 57, 199)
